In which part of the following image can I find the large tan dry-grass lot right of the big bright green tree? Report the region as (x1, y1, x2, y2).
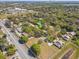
(39, 42, 58, 59)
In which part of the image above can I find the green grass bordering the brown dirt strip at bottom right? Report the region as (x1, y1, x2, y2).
(52, 44, 79, 59)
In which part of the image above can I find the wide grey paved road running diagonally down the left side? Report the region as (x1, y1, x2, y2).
(0, 21, 36, 59)
